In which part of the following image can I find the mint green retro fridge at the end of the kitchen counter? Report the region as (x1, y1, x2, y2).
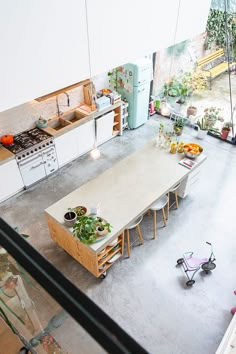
(117, 58, 152, 129)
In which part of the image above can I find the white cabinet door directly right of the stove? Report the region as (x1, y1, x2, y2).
(54, 130, 77, 167)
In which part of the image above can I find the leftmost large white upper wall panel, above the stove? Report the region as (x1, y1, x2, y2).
(0, 0, 89, 111)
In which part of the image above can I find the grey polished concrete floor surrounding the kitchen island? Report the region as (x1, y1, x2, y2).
(0, 73, 236, 354)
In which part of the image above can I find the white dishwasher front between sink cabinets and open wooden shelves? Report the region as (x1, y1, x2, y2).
(96, 111, 114, 145)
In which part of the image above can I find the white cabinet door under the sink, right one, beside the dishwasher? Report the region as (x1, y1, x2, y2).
(75, 120, 95, 156)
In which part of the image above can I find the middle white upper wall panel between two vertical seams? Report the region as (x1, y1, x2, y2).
(87, 0, 178, 76)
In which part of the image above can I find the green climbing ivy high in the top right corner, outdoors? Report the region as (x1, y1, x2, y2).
(205, 9, 233, 49)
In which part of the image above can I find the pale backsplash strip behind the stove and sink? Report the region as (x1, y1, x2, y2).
(0, 73, 109, 136)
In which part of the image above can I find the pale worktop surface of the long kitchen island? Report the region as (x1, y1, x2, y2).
(45, 140, 206, 252)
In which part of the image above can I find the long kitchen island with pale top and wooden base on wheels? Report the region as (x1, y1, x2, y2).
(45, 140, 206, 277)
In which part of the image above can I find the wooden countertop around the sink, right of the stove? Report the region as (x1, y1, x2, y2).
(41, 101, 121, 137)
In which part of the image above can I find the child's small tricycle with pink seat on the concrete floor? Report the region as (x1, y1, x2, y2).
(177, 242, 216, 286)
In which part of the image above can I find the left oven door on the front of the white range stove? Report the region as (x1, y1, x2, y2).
(19, 154, 46, 187)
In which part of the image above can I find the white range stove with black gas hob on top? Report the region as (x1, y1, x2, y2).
(5, 128, 58, 187)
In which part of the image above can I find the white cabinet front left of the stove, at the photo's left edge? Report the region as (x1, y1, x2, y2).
(0, 160, 24, 202)
